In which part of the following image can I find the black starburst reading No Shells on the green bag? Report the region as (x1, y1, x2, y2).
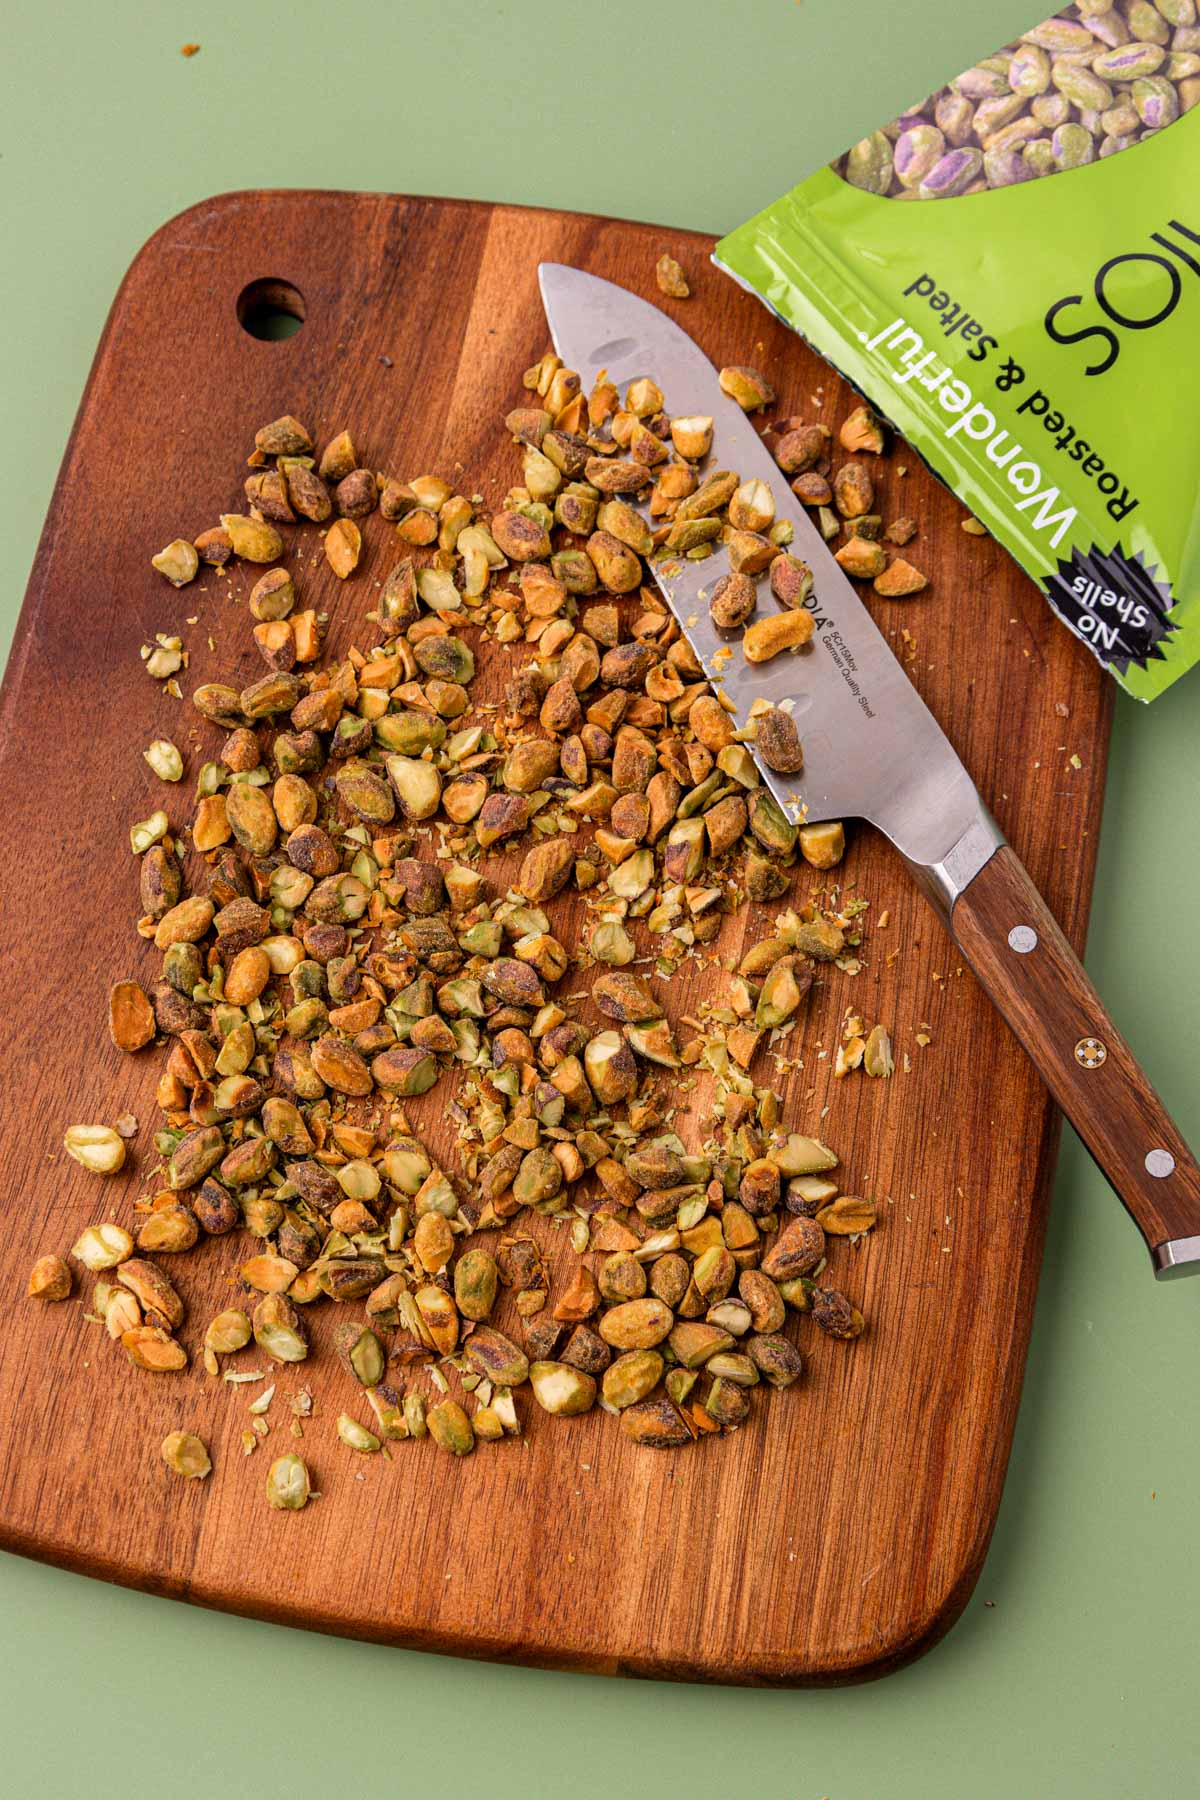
(1045, 544, 1177, 675)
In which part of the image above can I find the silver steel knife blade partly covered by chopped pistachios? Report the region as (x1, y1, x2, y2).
(538, 263, 1004, 904)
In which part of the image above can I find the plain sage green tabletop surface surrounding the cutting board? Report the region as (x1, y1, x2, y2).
(0, 0, 1200, 1800)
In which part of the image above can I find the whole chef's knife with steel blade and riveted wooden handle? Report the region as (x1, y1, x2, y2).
(538, 263, 1200, 1276)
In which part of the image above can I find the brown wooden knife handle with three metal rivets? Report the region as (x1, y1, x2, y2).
(950, 844, 1200, 1276)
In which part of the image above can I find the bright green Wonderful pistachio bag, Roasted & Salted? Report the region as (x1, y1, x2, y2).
(714, 0, 1200, 700)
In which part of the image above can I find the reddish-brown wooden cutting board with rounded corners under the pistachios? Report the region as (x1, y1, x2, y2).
(0, 193, 1112, 1683)
